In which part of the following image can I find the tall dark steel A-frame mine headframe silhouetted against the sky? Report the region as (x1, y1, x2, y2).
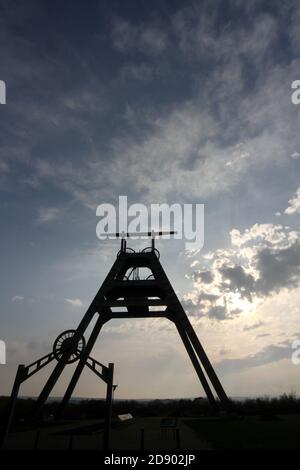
(30, 237, 231, 416)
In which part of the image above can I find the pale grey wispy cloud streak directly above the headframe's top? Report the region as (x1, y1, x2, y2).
(30, 102, 252, 209)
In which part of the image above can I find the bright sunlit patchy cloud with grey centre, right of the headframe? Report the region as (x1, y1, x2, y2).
(183, 220, 300, 320)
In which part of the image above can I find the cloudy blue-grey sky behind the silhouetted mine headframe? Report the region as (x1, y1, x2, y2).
(0, 0, 300, 398)
